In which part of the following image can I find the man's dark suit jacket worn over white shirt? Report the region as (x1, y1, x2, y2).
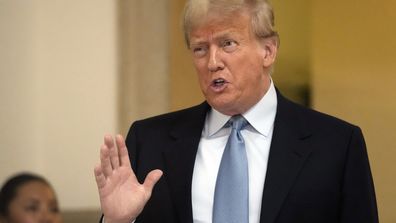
(126, 92, 378, 223)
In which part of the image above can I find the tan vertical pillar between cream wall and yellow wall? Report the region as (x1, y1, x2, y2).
(118, 0, 169, 134)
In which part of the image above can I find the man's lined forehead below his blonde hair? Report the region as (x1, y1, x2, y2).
(190, 12, 251, 42)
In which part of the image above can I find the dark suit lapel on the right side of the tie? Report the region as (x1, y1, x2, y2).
(260, 92, 311, 223)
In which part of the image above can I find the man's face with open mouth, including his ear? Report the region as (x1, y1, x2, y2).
(189, 9, 276, 115)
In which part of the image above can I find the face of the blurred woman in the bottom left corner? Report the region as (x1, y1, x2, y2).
(6, 181, 62, 223)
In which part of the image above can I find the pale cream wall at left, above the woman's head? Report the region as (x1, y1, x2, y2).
(0, 0, 117, 209)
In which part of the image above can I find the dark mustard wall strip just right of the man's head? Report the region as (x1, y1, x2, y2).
(271, 0, 312, 104)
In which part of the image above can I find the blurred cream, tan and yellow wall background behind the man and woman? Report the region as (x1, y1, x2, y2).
(0, 0, 396, 223)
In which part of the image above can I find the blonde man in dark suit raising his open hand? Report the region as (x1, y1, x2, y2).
(95, 0, 378, 223)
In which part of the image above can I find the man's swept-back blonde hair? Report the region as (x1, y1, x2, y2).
(183, 0, 279, 47)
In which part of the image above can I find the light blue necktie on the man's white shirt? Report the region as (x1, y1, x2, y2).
(213, 115, 249, 223)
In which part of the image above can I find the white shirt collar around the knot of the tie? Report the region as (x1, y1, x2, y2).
(204, 80, 278, 137)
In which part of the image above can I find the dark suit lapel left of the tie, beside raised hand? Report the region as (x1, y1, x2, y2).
(163, 103, 209, 223)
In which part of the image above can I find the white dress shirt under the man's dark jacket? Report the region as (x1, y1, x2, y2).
(191, 81, 277, 223)
